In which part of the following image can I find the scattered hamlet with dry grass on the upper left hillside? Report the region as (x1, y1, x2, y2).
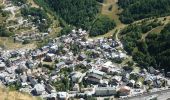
(2, 0, 51, 44)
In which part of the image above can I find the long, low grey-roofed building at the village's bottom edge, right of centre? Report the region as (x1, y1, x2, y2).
(95, 87, 116, 96)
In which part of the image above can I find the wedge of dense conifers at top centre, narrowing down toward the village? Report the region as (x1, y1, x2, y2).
(42, 0, 99, 29)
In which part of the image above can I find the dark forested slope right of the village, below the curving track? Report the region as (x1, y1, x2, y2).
(121, 21, 170, 71)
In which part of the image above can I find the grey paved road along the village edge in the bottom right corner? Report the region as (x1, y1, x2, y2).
(121, 89, 170, 100)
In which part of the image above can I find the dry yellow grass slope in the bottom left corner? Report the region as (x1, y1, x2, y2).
(0, 87, 41, 100)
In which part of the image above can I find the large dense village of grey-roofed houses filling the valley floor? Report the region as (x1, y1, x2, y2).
(0, 29, 170, 100)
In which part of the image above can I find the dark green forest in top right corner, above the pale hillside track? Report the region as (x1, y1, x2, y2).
(118, 0, 170, 24)
